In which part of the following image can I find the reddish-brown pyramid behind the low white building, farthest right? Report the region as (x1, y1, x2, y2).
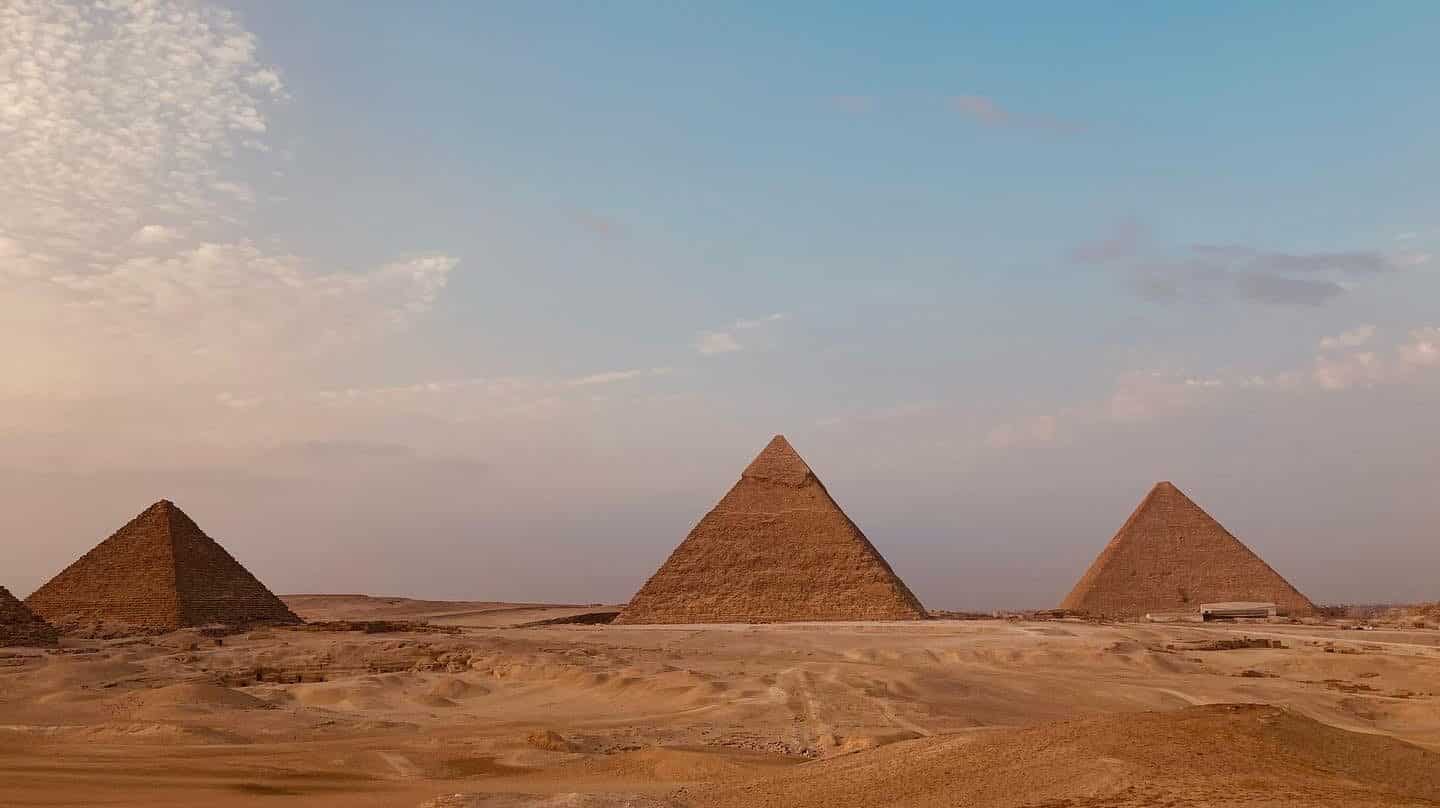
(1060, 482, 1315, 618)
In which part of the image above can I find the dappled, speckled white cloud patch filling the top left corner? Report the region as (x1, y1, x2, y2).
(0, 0, 284, 252)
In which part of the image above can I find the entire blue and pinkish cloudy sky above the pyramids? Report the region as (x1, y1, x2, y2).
(0, 0, 1440, 609)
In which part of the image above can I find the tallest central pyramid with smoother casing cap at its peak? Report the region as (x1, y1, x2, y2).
(615, 435, 926, 624)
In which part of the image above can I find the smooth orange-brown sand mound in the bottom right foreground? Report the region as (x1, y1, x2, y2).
(691, 704, 1440, 808)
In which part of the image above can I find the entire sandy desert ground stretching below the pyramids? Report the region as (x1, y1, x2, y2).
(0, 596, 1440, 808)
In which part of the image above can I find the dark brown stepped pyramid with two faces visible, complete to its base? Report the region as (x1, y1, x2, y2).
(26, 500, 301, 631)
